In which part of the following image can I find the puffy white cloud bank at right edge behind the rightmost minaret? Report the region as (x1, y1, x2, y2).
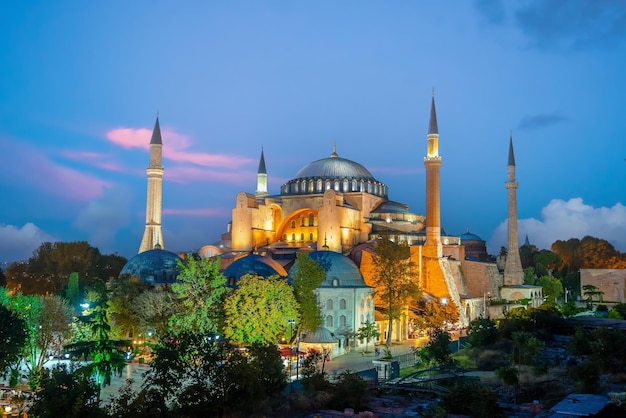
(489, 197, 626, 254)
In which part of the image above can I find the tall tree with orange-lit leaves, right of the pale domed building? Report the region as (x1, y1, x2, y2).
(372, 235, 419, 349)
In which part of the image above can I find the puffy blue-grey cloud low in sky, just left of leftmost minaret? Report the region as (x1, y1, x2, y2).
(73, 186, 132, 252)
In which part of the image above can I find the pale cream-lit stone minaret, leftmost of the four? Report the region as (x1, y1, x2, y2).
(139, 115, 165, 253)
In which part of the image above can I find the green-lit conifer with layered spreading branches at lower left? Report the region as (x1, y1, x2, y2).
(65, 282, 129, 387)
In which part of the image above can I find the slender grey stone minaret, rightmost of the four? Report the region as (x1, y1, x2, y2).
(504, 134, 524, 286)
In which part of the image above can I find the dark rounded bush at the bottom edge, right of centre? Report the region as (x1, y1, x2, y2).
(441, 381, 505, 418)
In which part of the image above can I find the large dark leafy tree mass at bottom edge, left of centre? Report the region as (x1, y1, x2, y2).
(144, 332, 286, 416)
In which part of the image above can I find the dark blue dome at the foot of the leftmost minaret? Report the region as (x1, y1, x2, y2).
(120, 249, 183, 284)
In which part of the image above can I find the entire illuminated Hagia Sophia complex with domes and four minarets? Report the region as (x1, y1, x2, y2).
(121, 94, 543, 355)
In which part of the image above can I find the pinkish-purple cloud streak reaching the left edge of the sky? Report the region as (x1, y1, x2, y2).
(0, 138, 109, 202)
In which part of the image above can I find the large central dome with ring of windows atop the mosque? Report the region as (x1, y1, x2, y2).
(281, 150, 387, 197)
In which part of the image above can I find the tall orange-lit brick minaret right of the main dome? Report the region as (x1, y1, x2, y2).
(424, 90, 442, 258)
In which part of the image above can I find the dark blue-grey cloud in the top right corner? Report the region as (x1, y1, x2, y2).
(474, 0, 626, 50)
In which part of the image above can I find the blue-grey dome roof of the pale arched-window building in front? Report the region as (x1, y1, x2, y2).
(289, 251, 367, 287)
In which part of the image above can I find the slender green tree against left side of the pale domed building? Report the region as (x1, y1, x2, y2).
(290, 252, 326, 331)
